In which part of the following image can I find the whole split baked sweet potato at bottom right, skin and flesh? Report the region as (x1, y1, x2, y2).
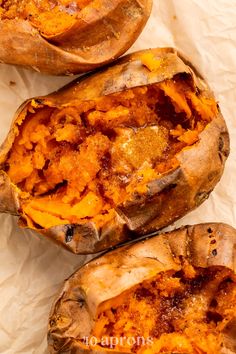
(48, 223, 236, 354)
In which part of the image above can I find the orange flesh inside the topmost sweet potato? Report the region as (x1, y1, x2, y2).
(0, 0, 93, 36)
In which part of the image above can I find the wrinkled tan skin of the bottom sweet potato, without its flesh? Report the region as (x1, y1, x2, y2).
(48, 223, 236, 354)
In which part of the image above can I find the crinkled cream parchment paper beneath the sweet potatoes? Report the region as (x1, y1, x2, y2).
(0, 0, 236, 354)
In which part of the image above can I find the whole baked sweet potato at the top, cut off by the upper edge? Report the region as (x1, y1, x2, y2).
(0, 0, 152, 75)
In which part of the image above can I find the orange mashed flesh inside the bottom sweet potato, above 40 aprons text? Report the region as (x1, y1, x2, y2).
(92, 263, 236, 354)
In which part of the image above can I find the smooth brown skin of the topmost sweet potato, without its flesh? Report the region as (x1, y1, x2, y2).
(0, 0, 152, 75)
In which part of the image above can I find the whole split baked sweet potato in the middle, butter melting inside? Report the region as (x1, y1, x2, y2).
(0, 49, 229, 253)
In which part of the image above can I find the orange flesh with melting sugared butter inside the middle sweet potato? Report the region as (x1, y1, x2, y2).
(6, 77, 217, 228)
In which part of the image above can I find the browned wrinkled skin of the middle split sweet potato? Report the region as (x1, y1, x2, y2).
(0, 48, 229, 254)
